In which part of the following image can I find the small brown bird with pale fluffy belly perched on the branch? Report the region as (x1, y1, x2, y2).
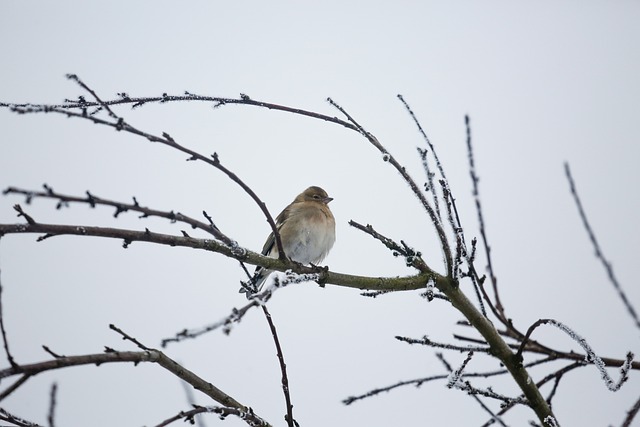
(246, 186, 336, 292)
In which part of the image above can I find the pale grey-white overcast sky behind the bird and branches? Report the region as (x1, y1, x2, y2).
(0, 1, 640, 426)
